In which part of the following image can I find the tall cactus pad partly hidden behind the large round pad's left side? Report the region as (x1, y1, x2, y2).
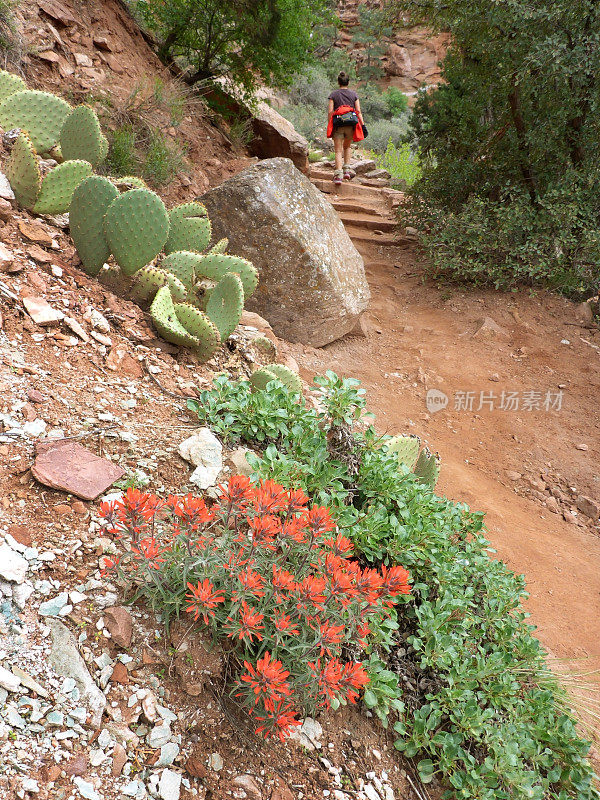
(69, 175, 119, 276)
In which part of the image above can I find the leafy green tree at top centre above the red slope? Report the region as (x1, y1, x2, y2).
(136, 0, 329, 91)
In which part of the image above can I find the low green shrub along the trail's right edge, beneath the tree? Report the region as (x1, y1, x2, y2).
(403, 178, 600, 297)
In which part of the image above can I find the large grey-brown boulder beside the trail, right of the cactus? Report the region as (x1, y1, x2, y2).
(202, 158, 369, 347)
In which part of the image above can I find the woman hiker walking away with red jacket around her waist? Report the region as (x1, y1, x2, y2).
(327, 72, 365, 184)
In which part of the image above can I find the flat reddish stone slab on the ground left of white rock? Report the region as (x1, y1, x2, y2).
(31, 441, 125, 500)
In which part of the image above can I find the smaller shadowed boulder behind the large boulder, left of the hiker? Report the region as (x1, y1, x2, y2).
(249, 101, 308, 172)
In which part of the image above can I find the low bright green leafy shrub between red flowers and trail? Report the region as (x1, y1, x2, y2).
(188, 373, 599, 800)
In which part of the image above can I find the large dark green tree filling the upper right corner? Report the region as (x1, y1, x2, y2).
(392, 0, 600, 294)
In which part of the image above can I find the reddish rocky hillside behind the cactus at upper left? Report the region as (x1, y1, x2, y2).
(8, 0, 254, 201)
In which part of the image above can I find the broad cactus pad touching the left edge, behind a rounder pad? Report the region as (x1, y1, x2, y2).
(0, 89, 71, 153)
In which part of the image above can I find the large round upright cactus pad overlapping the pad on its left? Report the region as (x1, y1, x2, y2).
(104, 189, 169, 275)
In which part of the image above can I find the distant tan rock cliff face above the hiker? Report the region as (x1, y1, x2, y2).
(338, 0, 450, 95)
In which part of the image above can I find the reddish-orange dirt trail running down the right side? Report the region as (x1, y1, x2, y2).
(295, 167, 600, 671)
